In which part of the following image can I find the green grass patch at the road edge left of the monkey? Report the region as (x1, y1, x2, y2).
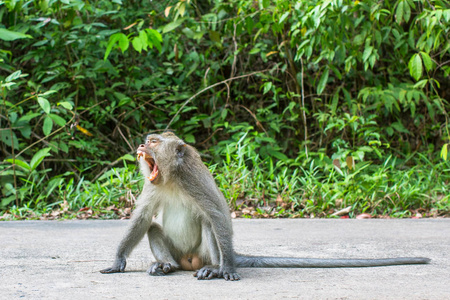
(0, 160, 142, 220)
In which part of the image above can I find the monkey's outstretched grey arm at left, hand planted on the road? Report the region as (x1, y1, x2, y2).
(100, 206, 153, 274)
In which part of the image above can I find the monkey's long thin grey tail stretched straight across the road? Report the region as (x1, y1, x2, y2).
(235, 254, 431, 268)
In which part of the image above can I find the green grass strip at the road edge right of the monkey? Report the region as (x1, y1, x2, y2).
(212, 141, 450, 217)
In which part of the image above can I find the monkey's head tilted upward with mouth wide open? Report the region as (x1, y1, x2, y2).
(137, 132, 189, 184)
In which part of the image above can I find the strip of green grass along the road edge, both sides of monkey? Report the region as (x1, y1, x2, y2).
(0, 141, 450, 220)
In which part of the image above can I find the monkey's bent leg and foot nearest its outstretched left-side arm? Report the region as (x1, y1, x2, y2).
(147, 223, 180, 276)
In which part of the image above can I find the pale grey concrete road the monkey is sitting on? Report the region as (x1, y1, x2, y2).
(0, 219, 450, 300)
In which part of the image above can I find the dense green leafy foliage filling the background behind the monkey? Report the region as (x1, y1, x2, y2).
(0, 0, 450, 215)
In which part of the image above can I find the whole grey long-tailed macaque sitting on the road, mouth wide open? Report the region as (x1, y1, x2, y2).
(100, 132, 430, 280)
